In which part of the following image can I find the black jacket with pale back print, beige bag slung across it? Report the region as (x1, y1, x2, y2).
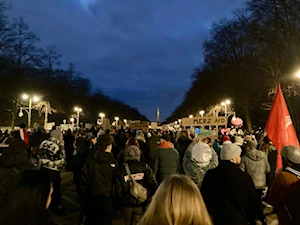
(114, 160, 158, 207)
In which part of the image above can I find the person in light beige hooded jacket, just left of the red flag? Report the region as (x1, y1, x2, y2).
(240, 140, 271, 221)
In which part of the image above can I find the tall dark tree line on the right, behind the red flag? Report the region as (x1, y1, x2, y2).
(168, 0, 300, 131)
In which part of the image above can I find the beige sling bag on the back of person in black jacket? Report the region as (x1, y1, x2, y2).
(125, 163, 147, 203)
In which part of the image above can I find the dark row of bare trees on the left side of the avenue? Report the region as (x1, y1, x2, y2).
(0, 1, 147, 126)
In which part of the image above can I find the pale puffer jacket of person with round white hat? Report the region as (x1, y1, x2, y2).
(182, 143, 219, 187)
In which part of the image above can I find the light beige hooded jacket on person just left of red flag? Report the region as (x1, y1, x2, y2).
(240, 149, 271, 189)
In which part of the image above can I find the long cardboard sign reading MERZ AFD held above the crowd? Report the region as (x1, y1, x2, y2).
(182, 116, 227, 127)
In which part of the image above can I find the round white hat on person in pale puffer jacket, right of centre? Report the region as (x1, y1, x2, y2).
(192, 142, 212, 167)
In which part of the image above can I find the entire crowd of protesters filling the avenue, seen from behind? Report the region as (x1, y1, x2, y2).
(0, 125, 300, 225)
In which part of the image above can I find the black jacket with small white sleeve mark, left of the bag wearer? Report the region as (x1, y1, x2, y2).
(80, 151, 117, 199)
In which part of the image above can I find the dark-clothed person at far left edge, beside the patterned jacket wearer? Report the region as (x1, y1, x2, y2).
(0, 138, 33, 203)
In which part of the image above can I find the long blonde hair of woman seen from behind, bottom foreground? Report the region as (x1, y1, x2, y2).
(139, 174, 212, 225)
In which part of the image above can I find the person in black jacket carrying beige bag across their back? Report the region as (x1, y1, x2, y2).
(114, 145, 157, 225)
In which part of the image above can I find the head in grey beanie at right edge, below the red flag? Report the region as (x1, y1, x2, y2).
(280, 145, 300, 171)
